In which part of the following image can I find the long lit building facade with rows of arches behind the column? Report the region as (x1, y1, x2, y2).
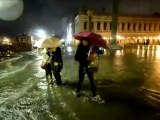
(75, 14, 160, 45)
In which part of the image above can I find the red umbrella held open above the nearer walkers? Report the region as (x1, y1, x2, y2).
(73, 32, 108, 48)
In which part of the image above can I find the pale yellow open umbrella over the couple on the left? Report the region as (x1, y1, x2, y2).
(40, 37, 61, 48)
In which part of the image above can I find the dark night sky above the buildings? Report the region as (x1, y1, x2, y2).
(0, 0, 160, 35)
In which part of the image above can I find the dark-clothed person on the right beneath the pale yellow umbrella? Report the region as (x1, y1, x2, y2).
(51, 47, 63, 85)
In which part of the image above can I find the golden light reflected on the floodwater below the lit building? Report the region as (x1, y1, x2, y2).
(106, 45, 160, 106)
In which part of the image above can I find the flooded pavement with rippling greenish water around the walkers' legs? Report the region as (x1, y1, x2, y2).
(0, 46, 160, 120)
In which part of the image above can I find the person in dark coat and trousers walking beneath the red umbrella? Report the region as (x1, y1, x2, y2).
(75, 39, 96, 97)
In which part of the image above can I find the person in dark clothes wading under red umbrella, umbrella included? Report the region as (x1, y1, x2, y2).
(73, 32, 109, 97)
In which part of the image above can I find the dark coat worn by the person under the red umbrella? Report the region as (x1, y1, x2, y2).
(74, 43, 90, 66)
